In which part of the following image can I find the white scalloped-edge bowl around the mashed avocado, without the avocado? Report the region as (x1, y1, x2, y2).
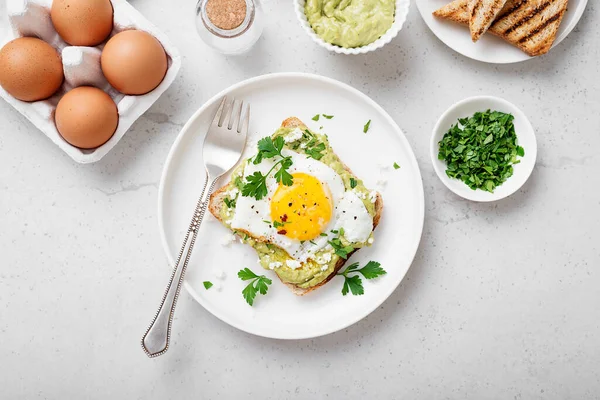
(294, 0, 410, 54)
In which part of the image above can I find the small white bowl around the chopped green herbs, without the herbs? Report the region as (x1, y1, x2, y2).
(431, 96, 537, 202)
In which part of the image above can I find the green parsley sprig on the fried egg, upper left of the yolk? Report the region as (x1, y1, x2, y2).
(242, 136, 293, 200)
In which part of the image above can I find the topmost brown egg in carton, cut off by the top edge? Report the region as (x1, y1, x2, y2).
(50, 0, 113, 46)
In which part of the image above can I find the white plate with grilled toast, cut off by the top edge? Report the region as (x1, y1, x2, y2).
(417, 0, 587, 64)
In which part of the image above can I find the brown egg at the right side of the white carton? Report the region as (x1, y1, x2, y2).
(101, 30, 167, 95)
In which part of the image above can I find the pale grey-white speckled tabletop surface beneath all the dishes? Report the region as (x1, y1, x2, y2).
(0, 0, 600, 399)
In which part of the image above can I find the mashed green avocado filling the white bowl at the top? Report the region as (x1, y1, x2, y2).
(304, 0, 395, 48)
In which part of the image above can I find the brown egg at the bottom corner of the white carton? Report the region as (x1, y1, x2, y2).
(54, 86, 119, 149)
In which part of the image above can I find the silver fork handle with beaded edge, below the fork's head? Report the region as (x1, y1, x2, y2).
(142, 174, 217, 358)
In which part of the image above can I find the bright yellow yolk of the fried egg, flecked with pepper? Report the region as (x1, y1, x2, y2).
(271, 172, 333, 240)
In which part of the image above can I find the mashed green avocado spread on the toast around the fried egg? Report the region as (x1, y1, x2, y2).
(220, 128, 375, 289)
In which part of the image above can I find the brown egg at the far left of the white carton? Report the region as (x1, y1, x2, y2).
(0, 37, 64, 101)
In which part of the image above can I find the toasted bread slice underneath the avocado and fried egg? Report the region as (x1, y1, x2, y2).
(208, 117, 383, 296)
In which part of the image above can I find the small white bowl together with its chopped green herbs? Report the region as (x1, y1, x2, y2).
(431, 96, 537, 202)
